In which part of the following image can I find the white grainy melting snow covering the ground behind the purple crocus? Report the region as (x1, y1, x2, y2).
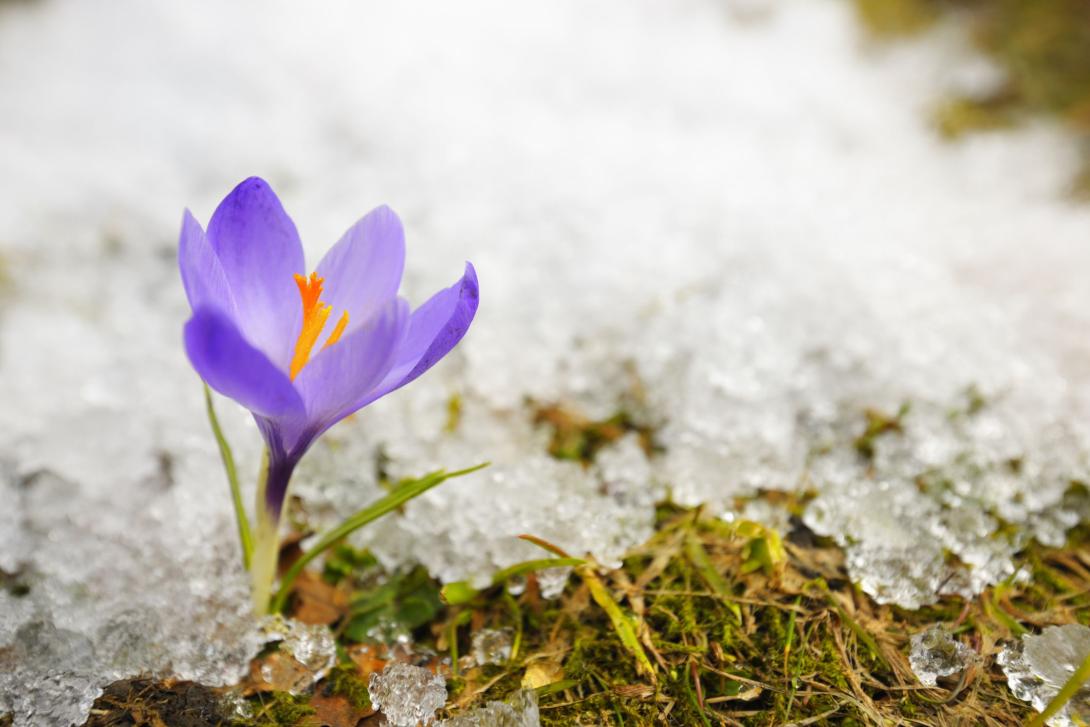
(0, 0, 1090, 725)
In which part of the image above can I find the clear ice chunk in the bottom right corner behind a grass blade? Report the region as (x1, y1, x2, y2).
(996, 623, 1090, 727)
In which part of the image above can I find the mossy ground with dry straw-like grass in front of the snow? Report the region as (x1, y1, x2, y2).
(244, 501, 1090, 727)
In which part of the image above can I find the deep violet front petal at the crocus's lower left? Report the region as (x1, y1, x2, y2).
(185, 307, 303, 416)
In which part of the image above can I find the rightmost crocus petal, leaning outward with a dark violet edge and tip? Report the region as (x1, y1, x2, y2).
(370, 263, 480, 401)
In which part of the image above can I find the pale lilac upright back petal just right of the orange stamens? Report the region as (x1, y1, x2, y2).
(317, 205, 405, 335)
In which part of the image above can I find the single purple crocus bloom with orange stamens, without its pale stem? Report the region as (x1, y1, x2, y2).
(178, 178, 477, 526)
